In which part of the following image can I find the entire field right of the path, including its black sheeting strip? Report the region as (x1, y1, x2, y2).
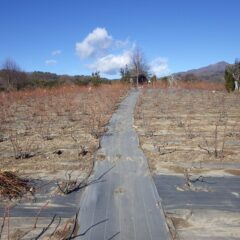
(135, 85, 240, 239)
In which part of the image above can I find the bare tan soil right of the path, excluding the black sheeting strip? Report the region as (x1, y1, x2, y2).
(135, 88, 240, 239)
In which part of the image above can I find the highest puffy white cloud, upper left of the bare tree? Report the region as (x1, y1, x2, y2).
(76, 28, 113, 59)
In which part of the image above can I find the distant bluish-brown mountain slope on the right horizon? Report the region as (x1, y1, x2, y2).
(174, 61, 229, 82)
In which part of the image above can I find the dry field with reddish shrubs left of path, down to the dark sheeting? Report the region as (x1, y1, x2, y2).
(0, 85, 126, 177)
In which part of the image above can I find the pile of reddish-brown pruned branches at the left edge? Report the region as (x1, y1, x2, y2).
(0, 171, 34, 199)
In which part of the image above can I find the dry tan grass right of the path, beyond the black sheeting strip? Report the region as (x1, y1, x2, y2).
(135, 84, 240, 173)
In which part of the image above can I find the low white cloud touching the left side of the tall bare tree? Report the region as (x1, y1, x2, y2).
(89, 51, 131, 75)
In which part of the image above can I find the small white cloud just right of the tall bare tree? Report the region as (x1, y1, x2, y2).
(149, 57, 170, 76)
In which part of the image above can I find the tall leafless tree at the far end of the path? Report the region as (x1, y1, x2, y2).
(131, 48, 149, 87)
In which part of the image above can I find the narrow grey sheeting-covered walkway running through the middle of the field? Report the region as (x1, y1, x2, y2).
(79, 91, 170, 240)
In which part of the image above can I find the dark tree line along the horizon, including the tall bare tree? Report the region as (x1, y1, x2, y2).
(0, 56, 240, 92)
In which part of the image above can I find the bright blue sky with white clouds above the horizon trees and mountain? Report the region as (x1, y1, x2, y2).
(0, 0, 240, 78)
